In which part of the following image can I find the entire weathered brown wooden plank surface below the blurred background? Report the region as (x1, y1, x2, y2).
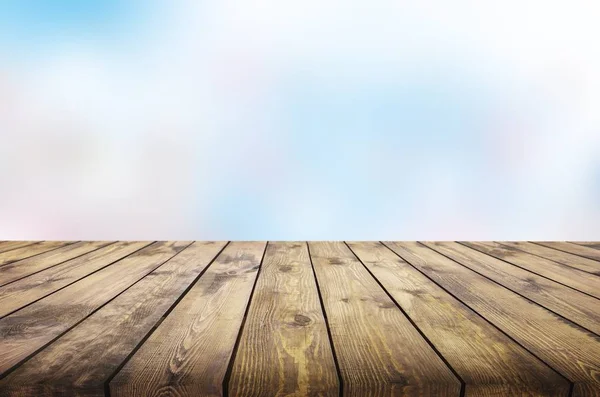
(0, 241, 600, 397)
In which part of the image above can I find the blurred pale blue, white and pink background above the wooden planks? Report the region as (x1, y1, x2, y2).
(0, 0, 600, 240)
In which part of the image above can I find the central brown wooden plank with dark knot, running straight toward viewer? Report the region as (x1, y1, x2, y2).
(229, 242, 339, 397)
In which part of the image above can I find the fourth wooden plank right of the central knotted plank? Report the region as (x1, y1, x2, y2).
(423, 242, 600, 335)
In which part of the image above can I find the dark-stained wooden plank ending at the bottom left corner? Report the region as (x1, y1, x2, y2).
(0, 242, 225, 397)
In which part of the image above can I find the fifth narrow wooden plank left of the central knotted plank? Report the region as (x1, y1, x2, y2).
(0, 241, 111, 287)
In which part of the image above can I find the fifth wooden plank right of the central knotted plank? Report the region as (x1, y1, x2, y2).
(462, 241, 600, 298)
